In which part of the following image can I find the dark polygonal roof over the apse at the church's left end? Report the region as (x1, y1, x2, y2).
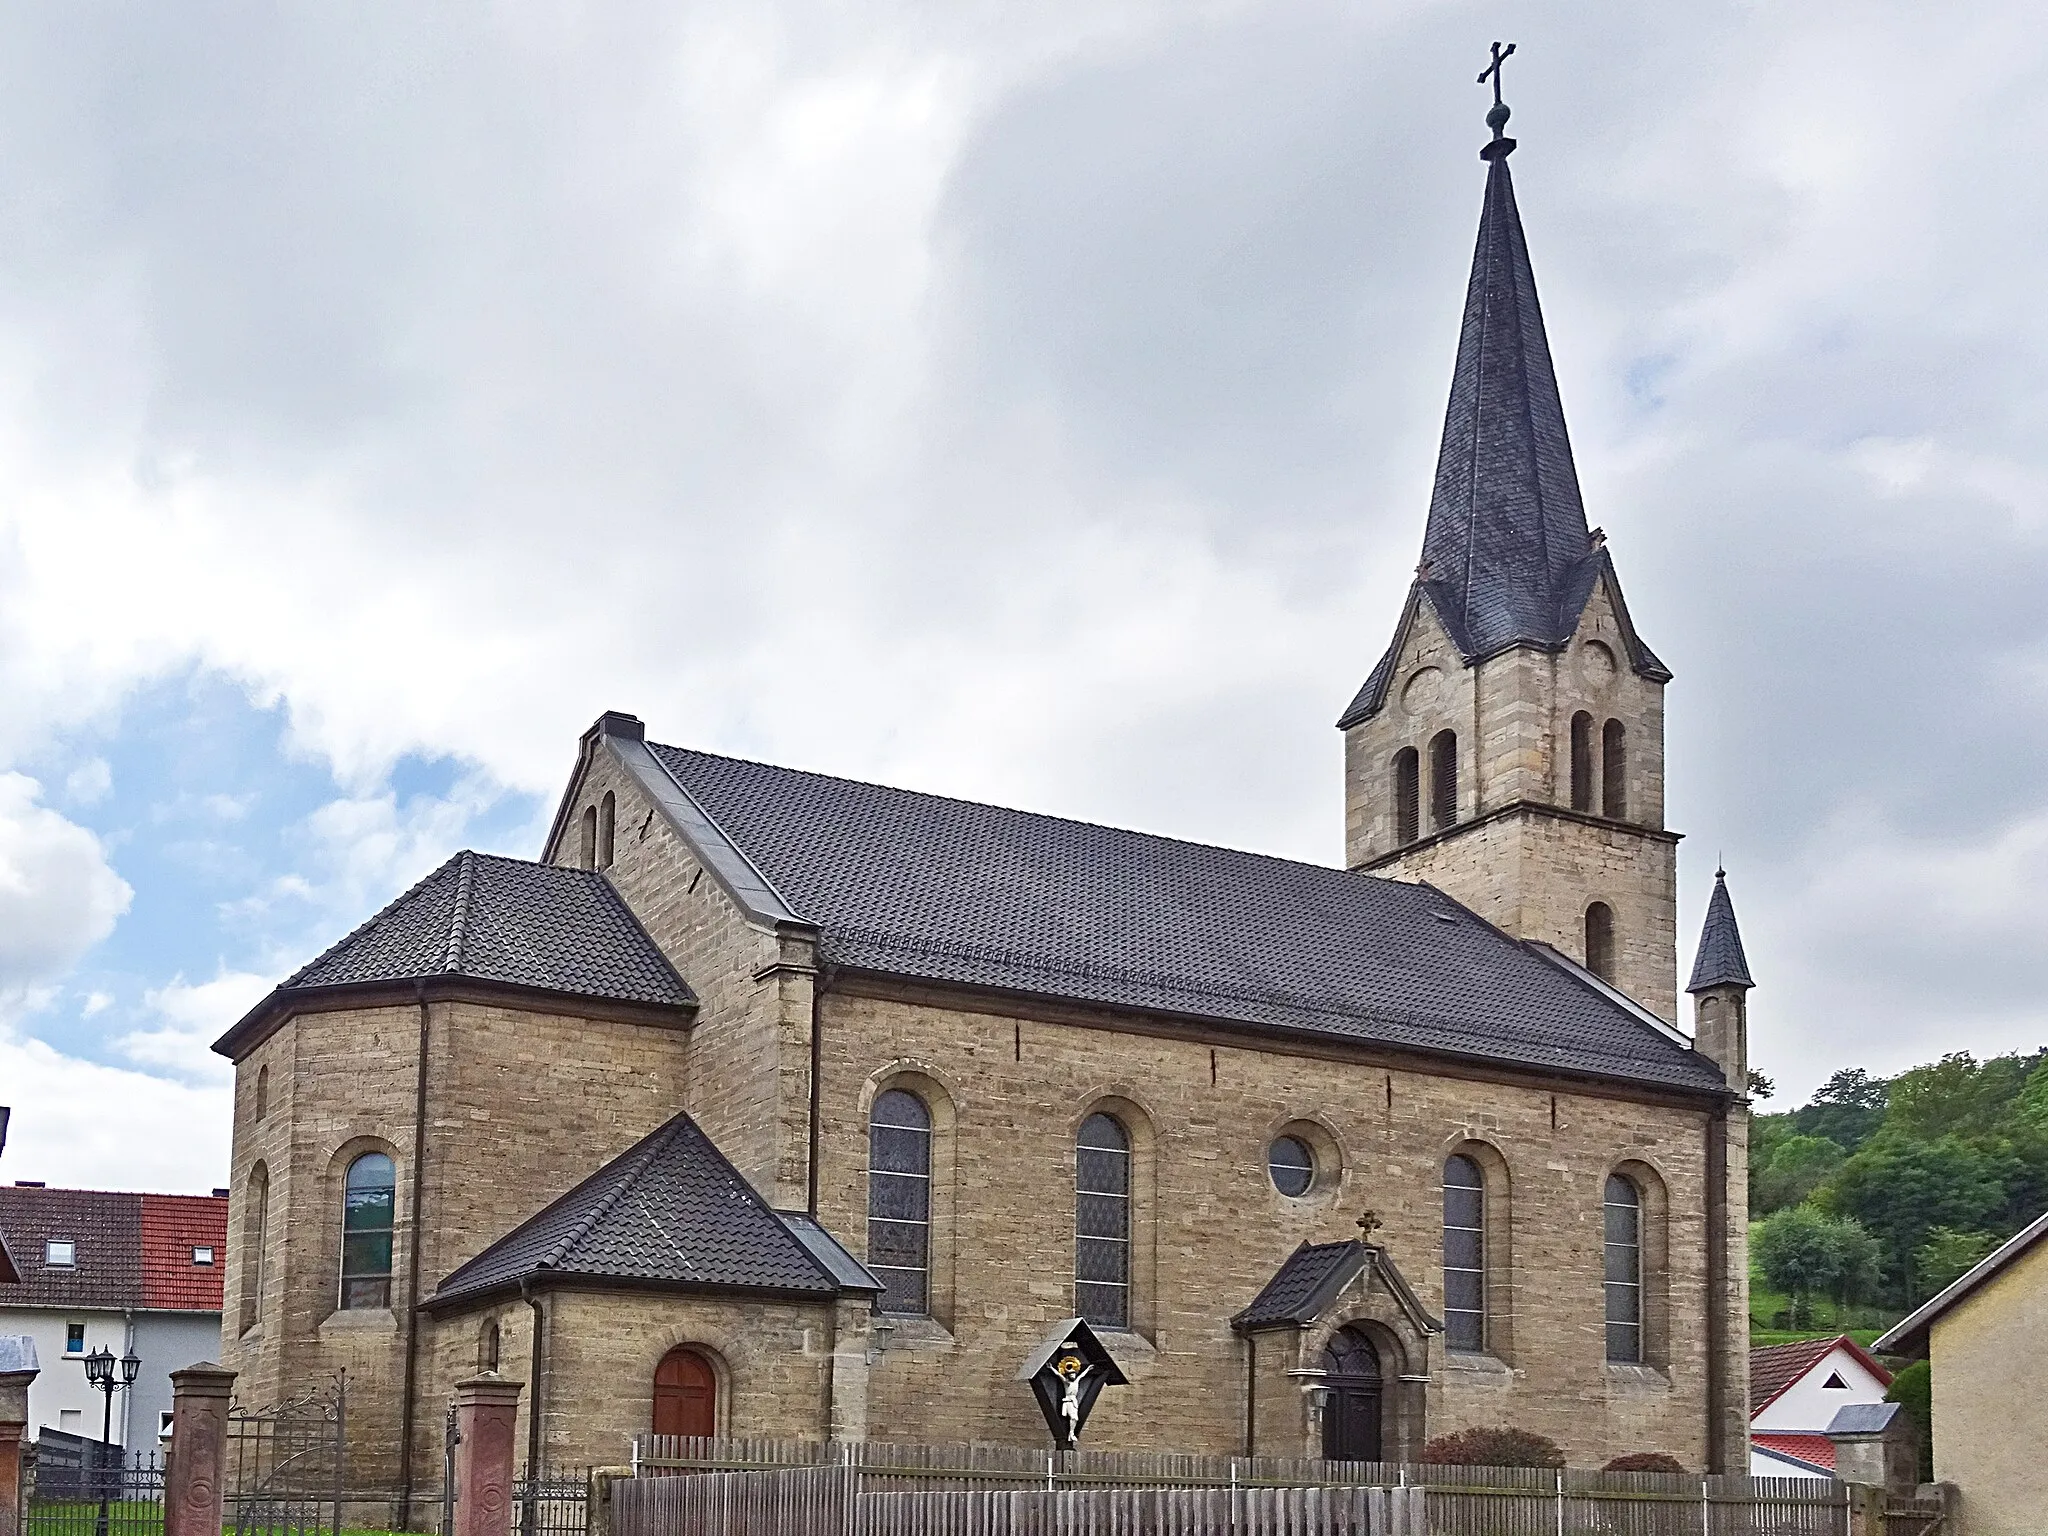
(213, 850, 696, 1051)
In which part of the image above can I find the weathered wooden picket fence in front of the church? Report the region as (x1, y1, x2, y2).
(612, 1438, 1849, 1536)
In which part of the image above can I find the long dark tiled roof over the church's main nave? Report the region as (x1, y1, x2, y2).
(651, 745, 1724, 1090)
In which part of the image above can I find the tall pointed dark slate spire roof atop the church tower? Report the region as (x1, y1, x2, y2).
(1337, 139, 1671, 727)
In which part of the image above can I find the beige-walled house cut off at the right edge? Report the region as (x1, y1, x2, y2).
(1874, 1212, 2048, 1536)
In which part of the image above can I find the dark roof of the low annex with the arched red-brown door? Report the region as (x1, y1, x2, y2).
(428, 1114, 883, 1309)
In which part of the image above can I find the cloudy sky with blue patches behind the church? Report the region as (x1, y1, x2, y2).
(0, 0, 2048, 1190)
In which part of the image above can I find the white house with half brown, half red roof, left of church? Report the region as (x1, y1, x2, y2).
(0, 1182, 227, 1454)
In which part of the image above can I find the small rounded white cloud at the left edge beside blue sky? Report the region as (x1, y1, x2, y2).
(0, 772, 133, 997)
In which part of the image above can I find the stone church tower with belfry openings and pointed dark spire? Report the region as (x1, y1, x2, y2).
(1337, 76, 1677, 1020)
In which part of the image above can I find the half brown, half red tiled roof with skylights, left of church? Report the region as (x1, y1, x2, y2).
(0, 1184, 227, 1313)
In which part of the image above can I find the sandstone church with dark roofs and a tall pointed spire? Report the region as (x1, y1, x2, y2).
(215, 78, 1751, 1518)
